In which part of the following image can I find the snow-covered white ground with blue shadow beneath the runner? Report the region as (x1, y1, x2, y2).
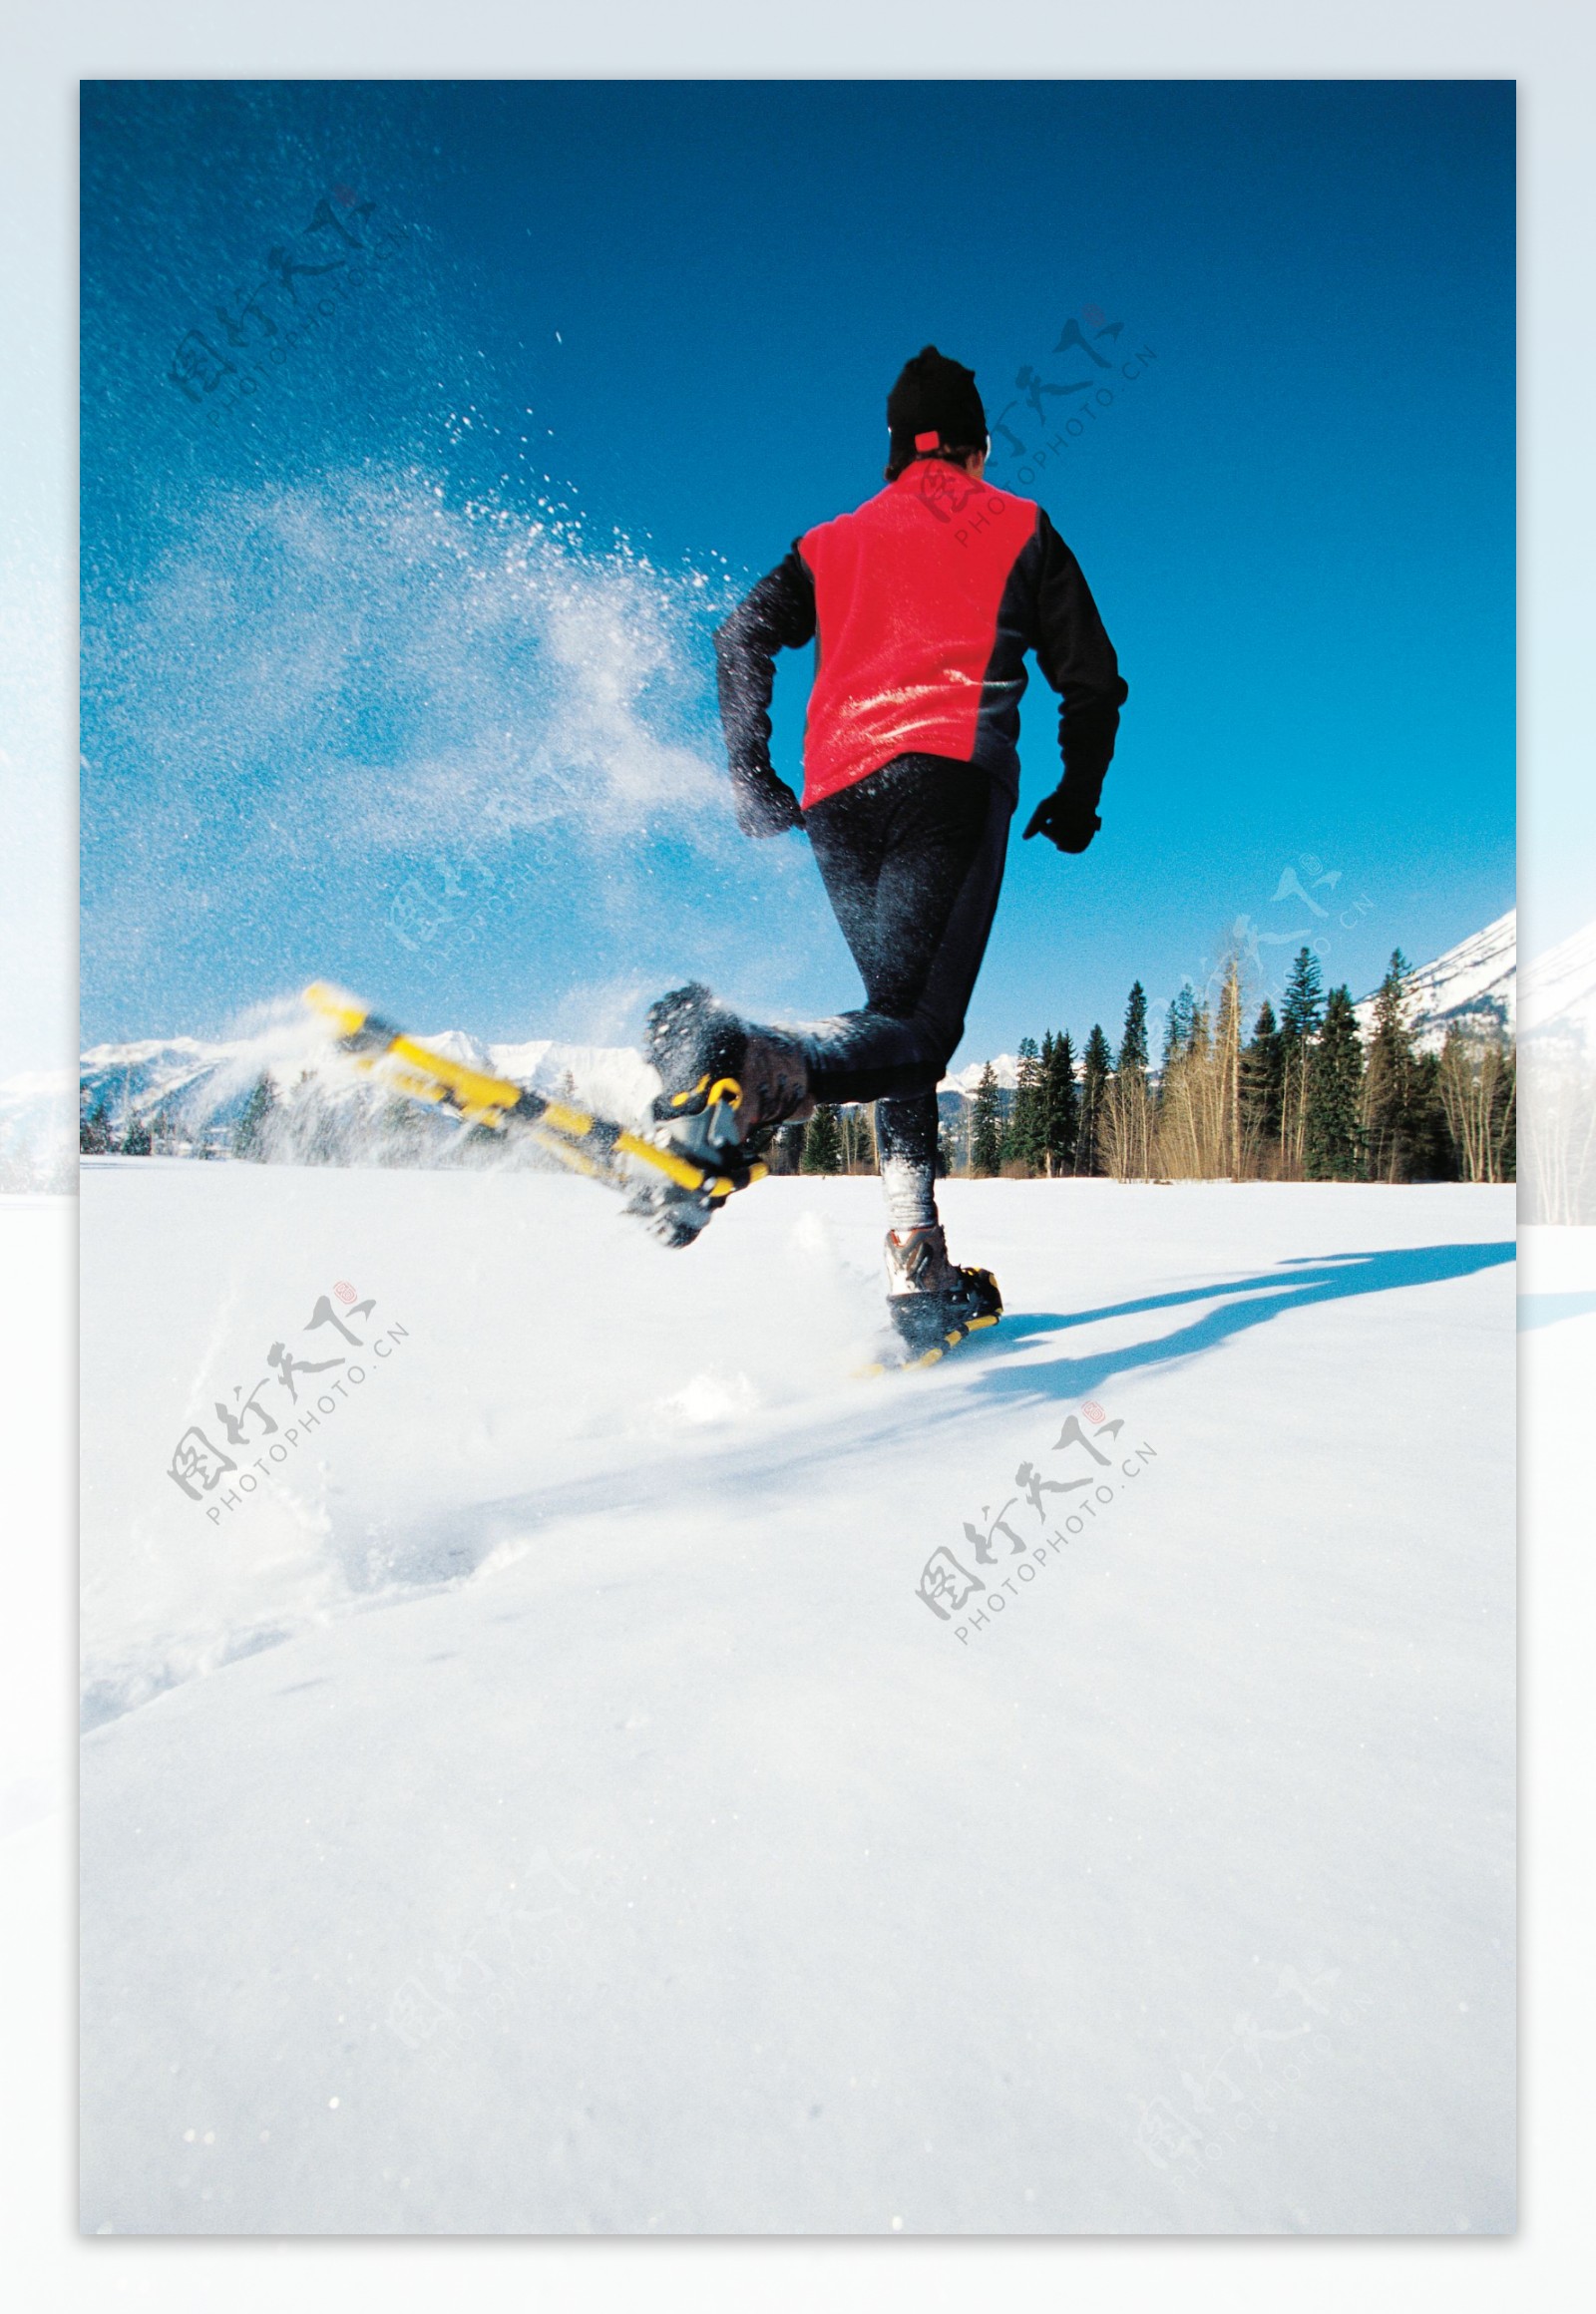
(81, 1159, 1515, 2233)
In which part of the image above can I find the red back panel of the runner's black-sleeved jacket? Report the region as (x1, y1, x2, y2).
(798, 458, 1036, 810)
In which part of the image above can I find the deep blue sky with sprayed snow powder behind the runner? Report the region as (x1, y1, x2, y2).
(83, 84, 1515, 1057)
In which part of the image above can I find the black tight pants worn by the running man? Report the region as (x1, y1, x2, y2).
(805, 754, 1015, 1164)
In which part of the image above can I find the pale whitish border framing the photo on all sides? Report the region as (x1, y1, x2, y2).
(0, 0, 1596, 2314)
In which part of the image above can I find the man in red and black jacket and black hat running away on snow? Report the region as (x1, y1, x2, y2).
(645, 345, 1126, 1340)
